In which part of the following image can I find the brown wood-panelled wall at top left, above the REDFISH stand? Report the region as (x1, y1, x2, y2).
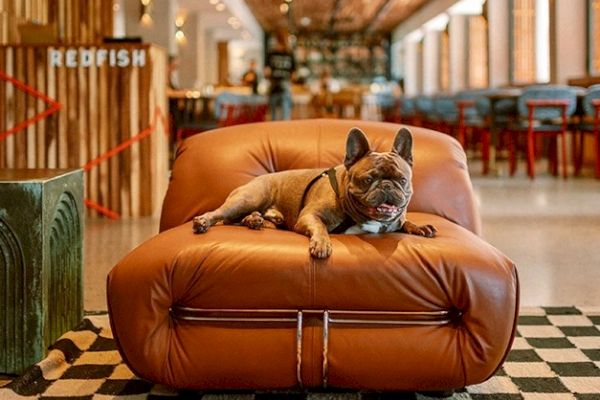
(0, 0, 113, 44)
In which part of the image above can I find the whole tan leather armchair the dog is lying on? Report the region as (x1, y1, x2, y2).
(108, 120, 518, 391)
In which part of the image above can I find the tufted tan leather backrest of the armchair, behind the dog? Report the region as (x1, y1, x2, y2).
(160, 119, 480, 234)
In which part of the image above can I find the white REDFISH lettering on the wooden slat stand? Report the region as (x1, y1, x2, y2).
(48, 48, 146, 68)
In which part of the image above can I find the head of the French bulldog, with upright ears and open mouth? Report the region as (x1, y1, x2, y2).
(344, 128, 412, 223)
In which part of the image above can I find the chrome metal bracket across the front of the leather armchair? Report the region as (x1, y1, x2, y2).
(170, 306, 452, 387)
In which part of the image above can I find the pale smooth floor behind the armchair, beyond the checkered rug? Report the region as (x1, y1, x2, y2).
(84, 168, 600, 311)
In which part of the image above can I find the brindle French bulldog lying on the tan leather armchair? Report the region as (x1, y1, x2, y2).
(193, 128, 437, 258)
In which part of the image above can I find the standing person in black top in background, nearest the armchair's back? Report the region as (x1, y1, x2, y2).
(265, 30, 296, 120)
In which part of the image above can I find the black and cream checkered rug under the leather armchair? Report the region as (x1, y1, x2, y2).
(0, 307, 600, 400)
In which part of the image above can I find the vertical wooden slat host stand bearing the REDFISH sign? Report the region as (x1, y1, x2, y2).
(0, 44, 168, 217)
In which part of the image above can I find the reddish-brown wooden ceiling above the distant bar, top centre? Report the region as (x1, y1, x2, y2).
(245, 0, 427, 34)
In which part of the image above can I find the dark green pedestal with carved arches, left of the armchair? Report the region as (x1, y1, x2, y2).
(0, 169, 83, 373)
